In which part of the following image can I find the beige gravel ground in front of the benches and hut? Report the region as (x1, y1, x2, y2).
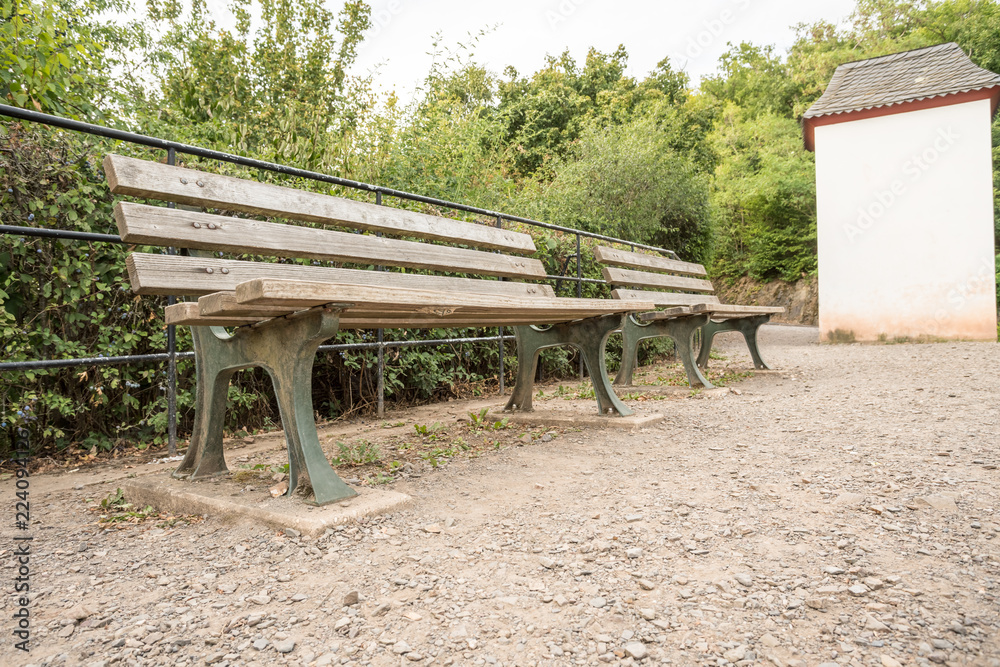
(0, 326, 1000, 667)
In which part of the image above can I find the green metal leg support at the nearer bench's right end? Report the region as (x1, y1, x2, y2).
(504, 314, 632, 417)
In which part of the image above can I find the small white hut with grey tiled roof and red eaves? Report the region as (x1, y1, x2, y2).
(803, 43, 1000, 342)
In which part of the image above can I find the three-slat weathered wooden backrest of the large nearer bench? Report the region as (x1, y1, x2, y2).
(104, 155, 555, 297)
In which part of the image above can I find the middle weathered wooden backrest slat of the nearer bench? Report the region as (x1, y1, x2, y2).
(115, 202, 546, 279)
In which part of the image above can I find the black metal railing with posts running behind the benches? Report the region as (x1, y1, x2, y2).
(0, 104, 678, 456)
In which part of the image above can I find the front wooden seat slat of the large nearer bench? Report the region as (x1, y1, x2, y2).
(236, 278, 653, 318)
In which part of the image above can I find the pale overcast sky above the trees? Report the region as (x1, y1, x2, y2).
(352, 0, 855, 102)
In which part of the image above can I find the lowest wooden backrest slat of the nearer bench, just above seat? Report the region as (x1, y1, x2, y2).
(125, 252, 555, 298)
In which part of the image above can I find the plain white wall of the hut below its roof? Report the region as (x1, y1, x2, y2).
(815, 100, 997, 341)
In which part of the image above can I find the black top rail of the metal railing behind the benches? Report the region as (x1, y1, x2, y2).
(0, 104, 677, 259)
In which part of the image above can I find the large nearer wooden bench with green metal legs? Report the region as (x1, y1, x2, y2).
(104, 155, 653, 504)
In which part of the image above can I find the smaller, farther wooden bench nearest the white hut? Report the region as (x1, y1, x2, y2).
(594, 246, 785, 388)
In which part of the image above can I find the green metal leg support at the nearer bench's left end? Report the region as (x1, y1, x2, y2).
(174, 308, 357, 505)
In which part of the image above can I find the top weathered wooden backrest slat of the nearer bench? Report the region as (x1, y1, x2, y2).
(104, 155, 535, 255)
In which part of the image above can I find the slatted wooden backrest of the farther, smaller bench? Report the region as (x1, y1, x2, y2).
(594, 246, 719, 307)
